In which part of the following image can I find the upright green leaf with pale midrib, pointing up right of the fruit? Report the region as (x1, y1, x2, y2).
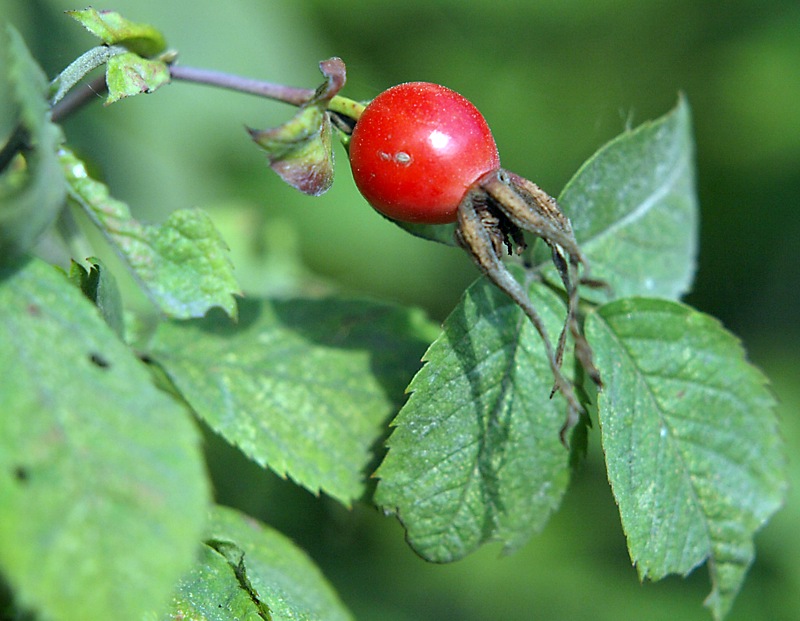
(536, 99, 698, 301)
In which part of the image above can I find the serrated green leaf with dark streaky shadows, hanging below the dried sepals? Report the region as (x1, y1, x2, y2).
(375, 268, 569, 562)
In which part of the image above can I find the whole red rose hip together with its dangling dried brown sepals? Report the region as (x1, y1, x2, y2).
(349, 82, 602, 439)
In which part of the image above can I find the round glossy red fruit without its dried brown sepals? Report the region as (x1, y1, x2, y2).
(350, 82, 500, 224)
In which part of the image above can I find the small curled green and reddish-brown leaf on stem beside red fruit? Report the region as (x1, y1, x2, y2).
(247, 58, 345, 196)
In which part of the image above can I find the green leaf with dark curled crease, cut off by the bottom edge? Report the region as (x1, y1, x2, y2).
(159, 507, 352, 621)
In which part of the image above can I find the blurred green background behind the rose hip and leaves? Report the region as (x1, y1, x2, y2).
(7, 0, 800, 621)
